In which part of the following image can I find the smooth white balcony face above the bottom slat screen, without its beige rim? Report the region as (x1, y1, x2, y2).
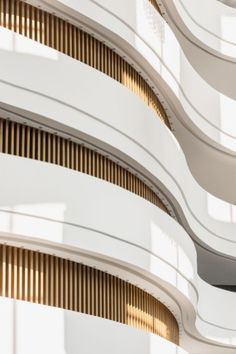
(0, 154, 197, 305)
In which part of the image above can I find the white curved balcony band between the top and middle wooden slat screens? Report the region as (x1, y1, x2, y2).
(0, 36, 236, 258)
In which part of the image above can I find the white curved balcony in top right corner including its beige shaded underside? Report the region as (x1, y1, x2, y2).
(162, 0, 236, 99)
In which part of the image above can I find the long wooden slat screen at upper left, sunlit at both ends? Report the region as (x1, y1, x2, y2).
(0, 0, 170, 128)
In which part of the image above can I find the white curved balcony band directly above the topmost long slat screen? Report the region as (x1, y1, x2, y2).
(24, 0, 236, 155)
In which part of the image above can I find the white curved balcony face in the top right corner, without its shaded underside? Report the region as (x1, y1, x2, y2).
(162, 0, 236, 62)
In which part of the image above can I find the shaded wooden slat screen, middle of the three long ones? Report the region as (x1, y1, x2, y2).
(0, 118, 169, 213)
